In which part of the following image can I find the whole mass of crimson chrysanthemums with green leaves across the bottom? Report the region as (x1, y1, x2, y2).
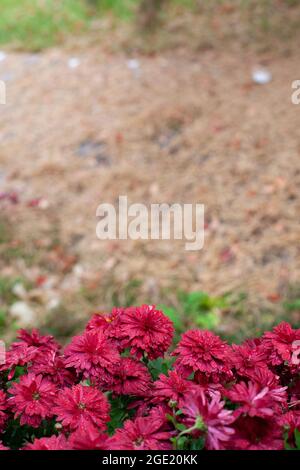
(0, 305, 300, 450)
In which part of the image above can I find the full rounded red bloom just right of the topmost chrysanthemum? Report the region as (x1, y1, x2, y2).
(173, 330, 231, 376)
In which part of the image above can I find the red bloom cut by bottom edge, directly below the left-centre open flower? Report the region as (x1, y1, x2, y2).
(69, 422, 108, 450)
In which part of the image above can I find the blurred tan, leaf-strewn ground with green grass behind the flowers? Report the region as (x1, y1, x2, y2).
(0, 0, 300, 341)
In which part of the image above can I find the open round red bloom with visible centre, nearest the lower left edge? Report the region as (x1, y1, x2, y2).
(8, 373, 57, 427)
